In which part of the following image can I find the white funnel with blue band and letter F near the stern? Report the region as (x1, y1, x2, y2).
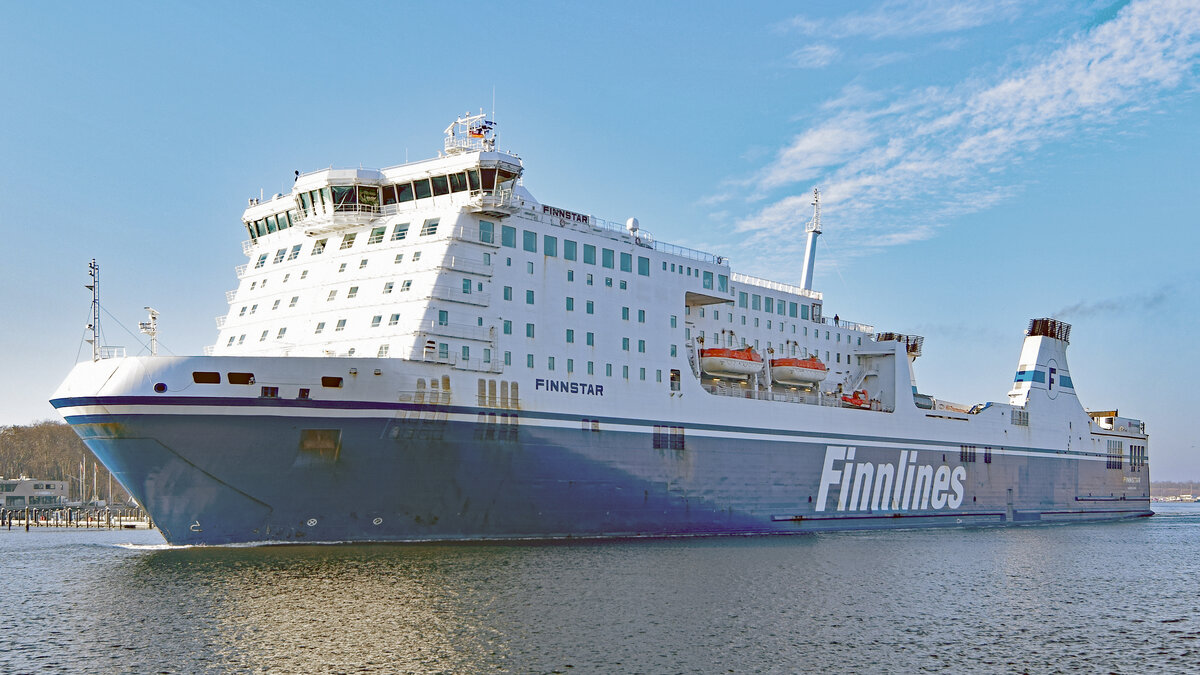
(1008, 318, 1075, 406)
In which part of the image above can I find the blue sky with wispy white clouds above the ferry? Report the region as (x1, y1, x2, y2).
(0, 0, 1200, 482)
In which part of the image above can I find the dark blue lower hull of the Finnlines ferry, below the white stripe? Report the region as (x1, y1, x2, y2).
(68, 401, 1150, 544)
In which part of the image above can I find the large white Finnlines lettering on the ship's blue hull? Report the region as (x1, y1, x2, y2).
(816, 446, 967, 512)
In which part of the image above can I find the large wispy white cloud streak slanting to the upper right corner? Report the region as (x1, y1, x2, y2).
(737, 0, 1200, 267)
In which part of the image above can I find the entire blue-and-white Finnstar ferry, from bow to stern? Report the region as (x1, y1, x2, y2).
(52, 114, 1151, 544)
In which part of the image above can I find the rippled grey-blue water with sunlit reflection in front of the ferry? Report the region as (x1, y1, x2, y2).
(0, 504, 1200, 674)
